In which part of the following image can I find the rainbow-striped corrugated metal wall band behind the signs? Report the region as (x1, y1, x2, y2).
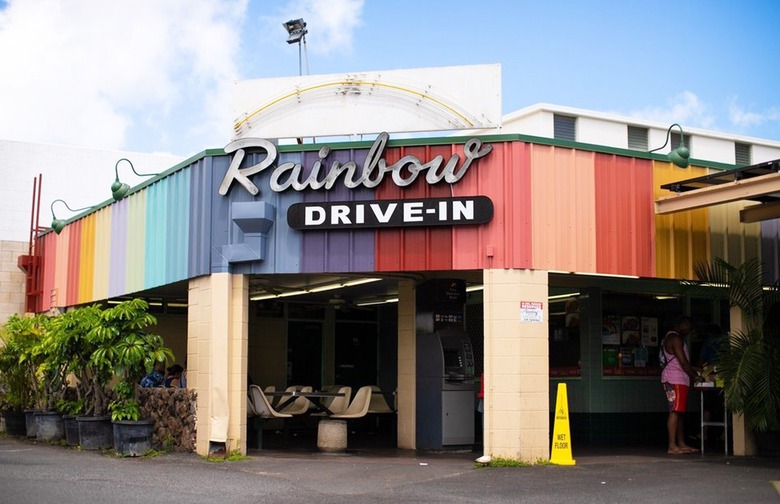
(35, 137, 768, 310)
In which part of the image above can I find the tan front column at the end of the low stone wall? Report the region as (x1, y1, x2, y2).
(187, 273, 249, 455)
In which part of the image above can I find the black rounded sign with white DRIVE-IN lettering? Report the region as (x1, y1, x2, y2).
(287, 196, 493, 229)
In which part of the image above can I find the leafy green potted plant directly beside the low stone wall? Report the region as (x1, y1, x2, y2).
(94, 299, 173, 456)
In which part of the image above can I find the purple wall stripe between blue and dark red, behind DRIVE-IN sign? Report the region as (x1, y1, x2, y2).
(300, 150, 375, 272)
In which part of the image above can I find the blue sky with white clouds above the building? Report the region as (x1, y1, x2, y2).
(0, 0, 780, 156)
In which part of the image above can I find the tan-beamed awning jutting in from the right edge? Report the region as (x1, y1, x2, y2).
(655, 159, 780, 222)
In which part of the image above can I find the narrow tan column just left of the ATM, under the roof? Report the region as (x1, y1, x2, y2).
(397, 280, 417, 449)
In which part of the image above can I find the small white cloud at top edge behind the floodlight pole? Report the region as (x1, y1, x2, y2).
(263, 0, 363, 54)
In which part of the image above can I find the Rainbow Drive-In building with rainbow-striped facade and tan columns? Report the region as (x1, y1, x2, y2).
(15, 65, 780, 461)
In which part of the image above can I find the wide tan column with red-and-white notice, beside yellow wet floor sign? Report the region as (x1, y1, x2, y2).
(483, 270, 550, 462)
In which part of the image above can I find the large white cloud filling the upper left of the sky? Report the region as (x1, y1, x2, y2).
(0, 0, 248, 154)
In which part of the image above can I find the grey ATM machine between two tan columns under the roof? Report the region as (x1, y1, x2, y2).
(416, 280, 475, 450)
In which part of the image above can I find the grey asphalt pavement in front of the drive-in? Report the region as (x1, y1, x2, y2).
(0, 437, 780, 504)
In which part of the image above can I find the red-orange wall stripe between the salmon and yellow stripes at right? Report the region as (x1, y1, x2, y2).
(595, 154, 655, 276)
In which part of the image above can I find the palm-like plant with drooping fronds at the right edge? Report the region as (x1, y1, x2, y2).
(694, 259, 780, 450)
